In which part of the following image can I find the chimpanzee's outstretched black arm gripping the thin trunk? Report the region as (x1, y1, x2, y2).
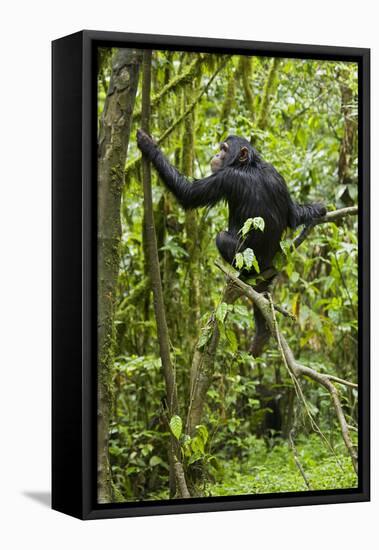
(137, 130, 225, 209)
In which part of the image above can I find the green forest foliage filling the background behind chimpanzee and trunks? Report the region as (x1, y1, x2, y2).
(98, 50, 358, 500)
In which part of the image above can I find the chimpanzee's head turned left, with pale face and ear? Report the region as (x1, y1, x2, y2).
(211, 136, 259, 172)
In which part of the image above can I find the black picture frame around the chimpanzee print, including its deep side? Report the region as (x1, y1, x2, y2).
(52, 30, 370, 519)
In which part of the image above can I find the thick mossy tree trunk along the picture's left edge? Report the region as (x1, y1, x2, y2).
(97, 49, 141, 503)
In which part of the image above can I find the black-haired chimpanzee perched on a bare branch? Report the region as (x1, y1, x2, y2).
(137, 130, 326, 357)
